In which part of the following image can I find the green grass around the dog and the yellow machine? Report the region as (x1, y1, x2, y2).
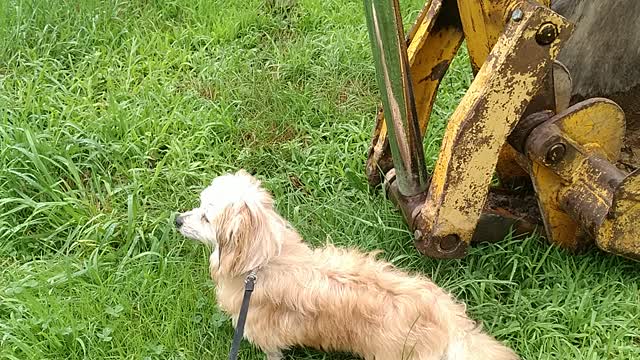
(0, 0, 640, 360)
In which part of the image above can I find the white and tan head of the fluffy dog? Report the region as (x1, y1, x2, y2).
(176, 170, 282, 276)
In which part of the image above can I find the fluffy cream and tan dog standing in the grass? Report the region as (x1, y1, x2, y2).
(176, 170, 519, 360)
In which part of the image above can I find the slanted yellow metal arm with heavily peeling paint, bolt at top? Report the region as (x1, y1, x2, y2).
(421, 2, 572, 243)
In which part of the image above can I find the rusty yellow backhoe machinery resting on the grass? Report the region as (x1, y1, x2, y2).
(364, 0, 640, 260)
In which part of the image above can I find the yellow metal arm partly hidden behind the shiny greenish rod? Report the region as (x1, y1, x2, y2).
(367, 0, 463, 184)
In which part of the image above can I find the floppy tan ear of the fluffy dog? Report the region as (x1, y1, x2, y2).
(218, 202, 282, 277)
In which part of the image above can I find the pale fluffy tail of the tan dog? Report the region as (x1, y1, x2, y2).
(446, 329, 520, 360)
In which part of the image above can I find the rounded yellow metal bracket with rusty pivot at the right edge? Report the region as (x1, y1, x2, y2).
(527, 98, 640, 259)
